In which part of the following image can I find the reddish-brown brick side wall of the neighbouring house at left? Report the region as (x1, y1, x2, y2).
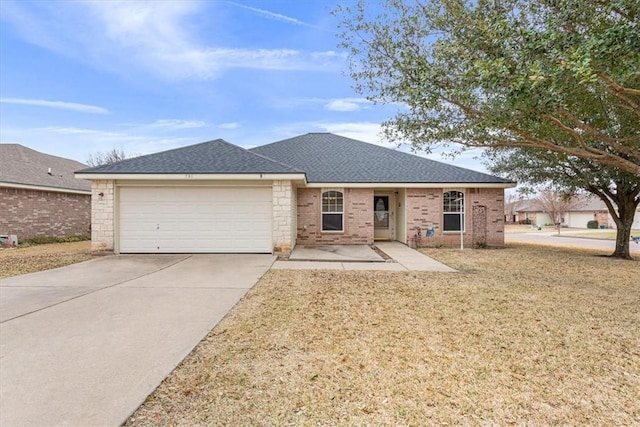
(0, 187, 91, 241)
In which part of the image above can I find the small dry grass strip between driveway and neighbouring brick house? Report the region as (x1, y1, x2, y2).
(0, 241, 92, 279)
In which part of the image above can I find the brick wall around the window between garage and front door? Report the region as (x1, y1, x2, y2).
(297, 188, 373, 245)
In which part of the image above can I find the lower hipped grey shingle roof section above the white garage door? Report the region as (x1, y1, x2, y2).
(78, 139, 303, 174)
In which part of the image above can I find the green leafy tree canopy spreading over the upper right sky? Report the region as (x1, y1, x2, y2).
(335, 0, 640, 176)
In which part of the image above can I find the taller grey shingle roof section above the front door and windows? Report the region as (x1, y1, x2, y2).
(250, 133, 511, 183)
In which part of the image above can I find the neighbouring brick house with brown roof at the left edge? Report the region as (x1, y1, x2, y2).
(0, 144, 91, 241)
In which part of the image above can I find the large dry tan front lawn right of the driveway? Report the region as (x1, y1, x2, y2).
(126, 245, 640, 426)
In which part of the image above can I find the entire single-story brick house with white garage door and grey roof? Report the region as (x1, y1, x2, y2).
(76, 133, 515, 254)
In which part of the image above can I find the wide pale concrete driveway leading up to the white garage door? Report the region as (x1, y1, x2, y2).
(0, 255, 275, 426)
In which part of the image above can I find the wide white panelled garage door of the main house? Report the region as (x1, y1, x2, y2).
(118, 187, 272, 253)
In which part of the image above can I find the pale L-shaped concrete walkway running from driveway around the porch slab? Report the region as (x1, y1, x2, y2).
(271, 242, 456, 272)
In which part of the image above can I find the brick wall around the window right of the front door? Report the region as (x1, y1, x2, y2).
(406, 188, 504, 247)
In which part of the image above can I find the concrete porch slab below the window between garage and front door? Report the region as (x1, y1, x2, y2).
(289, 245, 385, 262)
